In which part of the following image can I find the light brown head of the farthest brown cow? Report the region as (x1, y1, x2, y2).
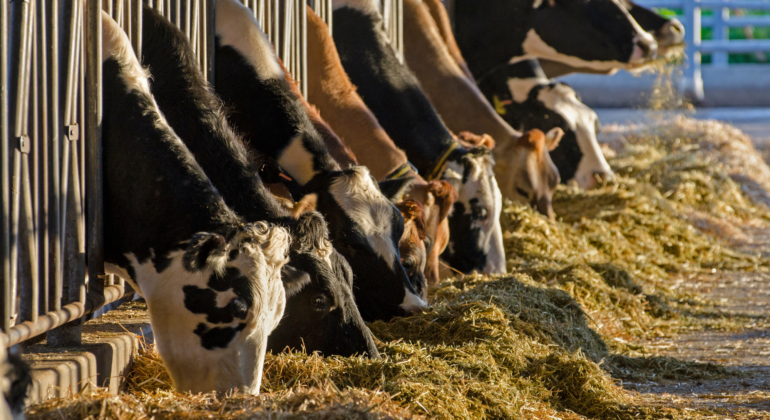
(495, 128, 564, 219)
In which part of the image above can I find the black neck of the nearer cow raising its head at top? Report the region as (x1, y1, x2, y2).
(455, 0, 537, 78)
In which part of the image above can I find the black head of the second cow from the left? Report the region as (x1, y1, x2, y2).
(268, 212, 379, 358)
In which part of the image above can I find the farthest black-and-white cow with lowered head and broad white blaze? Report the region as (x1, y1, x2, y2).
(478, 60, 612, 189)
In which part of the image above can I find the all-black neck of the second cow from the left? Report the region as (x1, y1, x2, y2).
(142, 6, 287, 225)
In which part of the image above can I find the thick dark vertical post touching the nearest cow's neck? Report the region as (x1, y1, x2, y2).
(85, 0, 104, 309)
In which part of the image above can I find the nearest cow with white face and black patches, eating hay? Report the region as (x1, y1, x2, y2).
(102, 13, 291, 394)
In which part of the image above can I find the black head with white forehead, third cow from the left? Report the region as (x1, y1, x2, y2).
(313, 166, 425, 321)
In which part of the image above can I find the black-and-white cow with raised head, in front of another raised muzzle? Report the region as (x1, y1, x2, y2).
(455, 0, 657, 78)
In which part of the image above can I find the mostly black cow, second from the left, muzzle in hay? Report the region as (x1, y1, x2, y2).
(142, 6, 378, 357)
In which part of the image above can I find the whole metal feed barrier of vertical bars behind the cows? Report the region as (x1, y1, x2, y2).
(0, 0, 348, 352)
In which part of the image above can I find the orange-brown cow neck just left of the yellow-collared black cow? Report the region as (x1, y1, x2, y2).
(307, 7, 409, 180)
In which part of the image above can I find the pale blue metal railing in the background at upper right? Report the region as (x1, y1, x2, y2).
(638, 0, 770, 99)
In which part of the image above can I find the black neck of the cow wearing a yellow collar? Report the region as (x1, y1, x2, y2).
(333, 7, 458, 180)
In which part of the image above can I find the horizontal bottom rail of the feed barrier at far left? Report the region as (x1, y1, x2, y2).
(8, 285, 124, 345)
